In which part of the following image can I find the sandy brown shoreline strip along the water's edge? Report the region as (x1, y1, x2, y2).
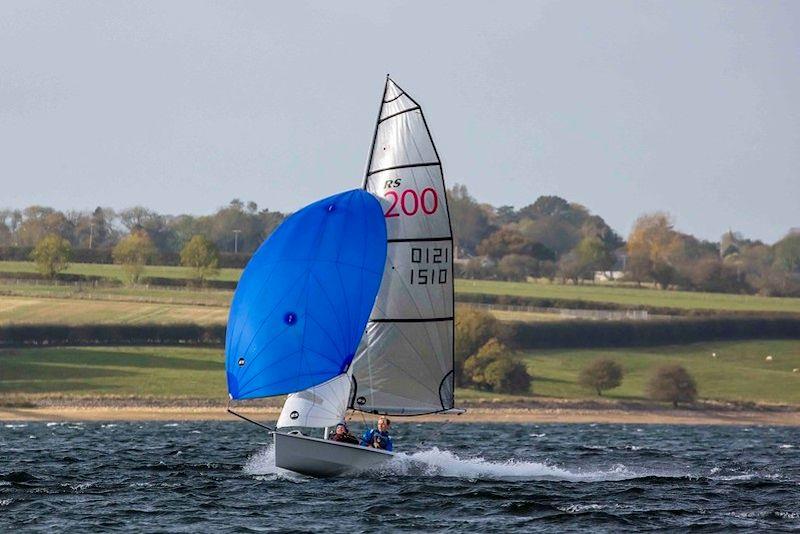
(0, 403, 800, 426)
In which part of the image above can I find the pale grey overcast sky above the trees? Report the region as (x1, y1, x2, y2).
(0, 0, 800, 242)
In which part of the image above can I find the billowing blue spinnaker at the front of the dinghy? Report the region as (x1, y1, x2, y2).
(225, 189, 386, 399)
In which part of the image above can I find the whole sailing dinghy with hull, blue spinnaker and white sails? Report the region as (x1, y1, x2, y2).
(225, 76, 458, 476)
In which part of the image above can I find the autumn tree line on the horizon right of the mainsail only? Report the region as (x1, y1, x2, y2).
(448, 185, 800, 296)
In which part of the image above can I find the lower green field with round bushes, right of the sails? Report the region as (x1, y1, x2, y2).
(522, 340, 800, 404)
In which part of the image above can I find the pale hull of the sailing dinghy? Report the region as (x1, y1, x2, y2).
(273, 432, 394, 477)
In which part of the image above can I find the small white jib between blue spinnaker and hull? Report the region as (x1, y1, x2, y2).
(278, 372, 352, 428)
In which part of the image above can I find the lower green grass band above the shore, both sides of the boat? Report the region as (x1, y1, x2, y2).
(0, 340, 800, 405)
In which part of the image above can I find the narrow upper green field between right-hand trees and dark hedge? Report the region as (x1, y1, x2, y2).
(456, 280, 800, 313)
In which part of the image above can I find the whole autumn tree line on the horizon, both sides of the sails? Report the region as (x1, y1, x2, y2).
(0, 185, 800, 296)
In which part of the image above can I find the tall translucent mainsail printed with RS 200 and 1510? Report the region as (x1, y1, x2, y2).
(353, 77, 454, 415)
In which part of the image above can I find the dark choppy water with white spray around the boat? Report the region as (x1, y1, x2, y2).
(0, 421, 800, 532)
